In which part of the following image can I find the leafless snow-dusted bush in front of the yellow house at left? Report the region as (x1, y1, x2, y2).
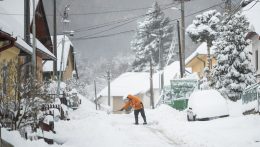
(0, 58, 50, 130)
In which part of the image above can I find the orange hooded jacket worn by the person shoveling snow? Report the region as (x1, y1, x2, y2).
(122, 94, 143, 110)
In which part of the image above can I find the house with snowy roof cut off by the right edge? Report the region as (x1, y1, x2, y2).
(242, 1, 260, 82)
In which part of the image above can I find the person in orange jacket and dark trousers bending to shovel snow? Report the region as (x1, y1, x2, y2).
(119, 94, 147, 125)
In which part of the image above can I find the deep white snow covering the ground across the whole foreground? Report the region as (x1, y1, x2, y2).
(3, 94, 260, 147)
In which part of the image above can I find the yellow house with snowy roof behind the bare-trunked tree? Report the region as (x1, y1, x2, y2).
(185, 42, 216, 78)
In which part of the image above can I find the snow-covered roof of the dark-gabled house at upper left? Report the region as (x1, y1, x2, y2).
(0, 0, 55, 59)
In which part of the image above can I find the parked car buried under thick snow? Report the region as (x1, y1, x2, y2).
(187, 90, 229, 121)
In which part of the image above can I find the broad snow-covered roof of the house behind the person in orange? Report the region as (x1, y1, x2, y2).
(98, 72, 159, 96)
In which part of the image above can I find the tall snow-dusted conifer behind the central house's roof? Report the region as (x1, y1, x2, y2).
(131, 2, 173, 71)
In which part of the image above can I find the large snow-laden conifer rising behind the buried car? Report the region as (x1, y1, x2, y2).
(212, 13, 256, 101)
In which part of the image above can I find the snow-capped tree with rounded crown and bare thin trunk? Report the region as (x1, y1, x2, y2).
(187, 10, 221, 72)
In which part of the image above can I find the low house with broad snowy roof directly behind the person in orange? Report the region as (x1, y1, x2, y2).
(98, 72, 159, 111)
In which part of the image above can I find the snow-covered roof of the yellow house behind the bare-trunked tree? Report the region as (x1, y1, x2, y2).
(185, 42, 215, 65)
